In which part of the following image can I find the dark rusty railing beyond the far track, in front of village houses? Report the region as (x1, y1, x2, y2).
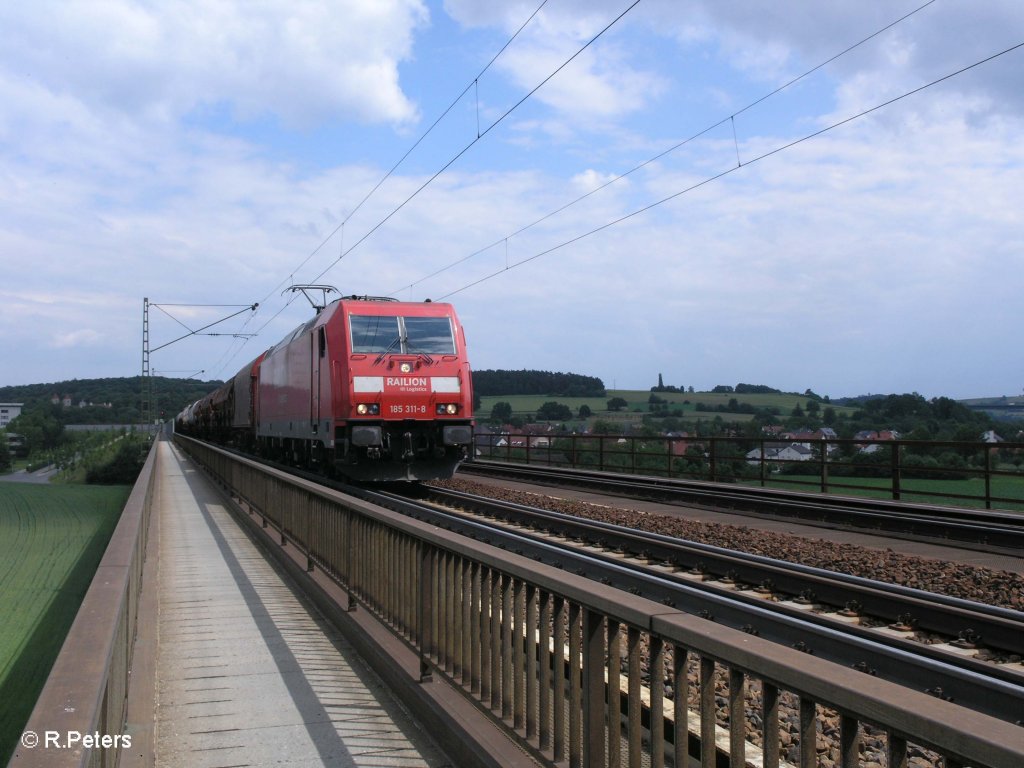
(474, 434, 1024, 509)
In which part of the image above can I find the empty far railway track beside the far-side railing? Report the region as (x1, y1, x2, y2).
(459, 461, 1024, 556)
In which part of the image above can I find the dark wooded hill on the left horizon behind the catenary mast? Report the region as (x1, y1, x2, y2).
(0, 376, 221, 424)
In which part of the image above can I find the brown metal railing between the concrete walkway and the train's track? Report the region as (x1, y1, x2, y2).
(178, 438, 1024, 768)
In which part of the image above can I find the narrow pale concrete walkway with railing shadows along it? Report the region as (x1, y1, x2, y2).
(155, 441, 451, 768)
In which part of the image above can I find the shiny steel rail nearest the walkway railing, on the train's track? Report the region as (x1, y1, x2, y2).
(338, 485, 1024, 723)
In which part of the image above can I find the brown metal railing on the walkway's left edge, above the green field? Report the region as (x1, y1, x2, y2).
(8, 441, 158, 768)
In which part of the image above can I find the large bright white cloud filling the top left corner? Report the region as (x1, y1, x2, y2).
(0, 0, 427, 126)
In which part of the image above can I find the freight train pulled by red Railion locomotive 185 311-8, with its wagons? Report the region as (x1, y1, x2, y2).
(175, 296, 473, 482)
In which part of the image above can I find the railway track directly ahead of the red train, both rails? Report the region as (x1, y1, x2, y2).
(335, 487, 1024, 723)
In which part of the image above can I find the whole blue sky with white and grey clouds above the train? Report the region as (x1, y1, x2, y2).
(0, 0, 1024, 397)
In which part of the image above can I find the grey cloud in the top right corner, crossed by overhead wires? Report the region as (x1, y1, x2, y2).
(659, 0, 1024, 120)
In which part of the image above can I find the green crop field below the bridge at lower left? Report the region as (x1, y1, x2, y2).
(0, 482, 131, 765)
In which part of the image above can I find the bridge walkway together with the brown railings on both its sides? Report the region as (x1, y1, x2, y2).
(10, 439, 1024, 768)
